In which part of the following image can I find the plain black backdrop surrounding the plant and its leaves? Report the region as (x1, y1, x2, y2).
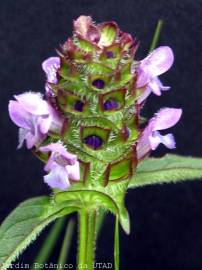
(0, 0, 202, 270)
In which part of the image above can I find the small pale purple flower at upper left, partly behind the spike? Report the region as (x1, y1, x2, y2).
(42, 57, 60, 96)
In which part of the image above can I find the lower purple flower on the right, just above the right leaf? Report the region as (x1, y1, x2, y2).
(137, 108, 182, 159)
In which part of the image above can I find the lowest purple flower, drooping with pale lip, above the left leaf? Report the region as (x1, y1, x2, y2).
(39, 142, 80, 190)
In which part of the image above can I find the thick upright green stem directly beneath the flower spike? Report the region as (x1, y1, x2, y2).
(77, 209, 97, 270)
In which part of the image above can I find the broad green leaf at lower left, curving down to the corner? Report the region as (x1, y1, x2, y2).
(0, 196, 76, 270)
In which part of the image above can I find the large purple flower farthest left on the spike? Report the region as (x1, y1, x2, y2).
(8, 92, 62, 149)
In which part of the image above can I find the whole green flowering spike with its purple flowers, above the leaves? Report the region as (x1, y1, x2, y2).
(9, 16, 181, 190)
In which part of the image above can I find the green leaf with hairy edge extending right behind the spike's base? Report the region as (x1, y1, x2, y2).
(129, 154, 202, 188)
